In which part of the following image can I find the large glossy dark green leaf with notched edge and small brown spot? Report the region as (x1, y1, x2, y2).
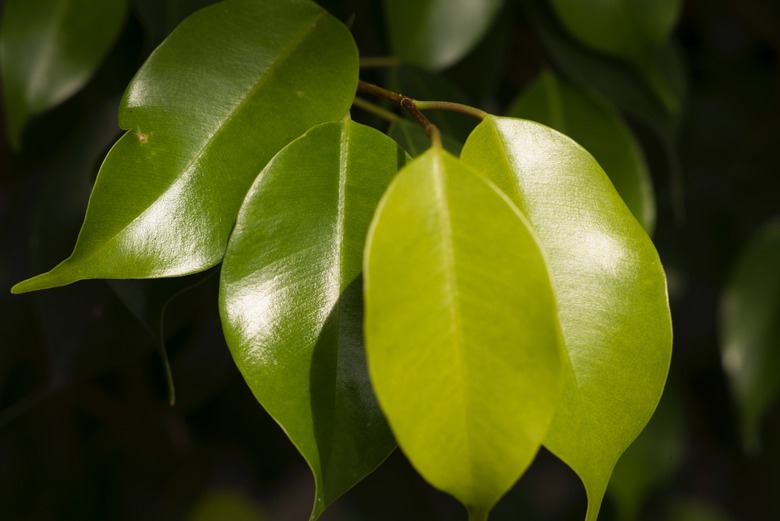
(13, 0, 358, 293)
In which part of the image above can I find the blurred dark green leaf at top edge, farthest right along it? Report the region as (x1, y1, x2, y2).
(551, 0, 682, 59)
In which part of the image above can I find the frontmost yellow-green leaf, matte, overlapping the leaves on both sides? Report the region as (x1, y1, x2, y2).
(365, 147, 562, 519)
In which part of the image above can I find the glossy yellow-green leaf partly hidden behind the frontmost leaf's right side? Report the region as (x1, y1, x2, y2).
(461, 116, 672, 521)
